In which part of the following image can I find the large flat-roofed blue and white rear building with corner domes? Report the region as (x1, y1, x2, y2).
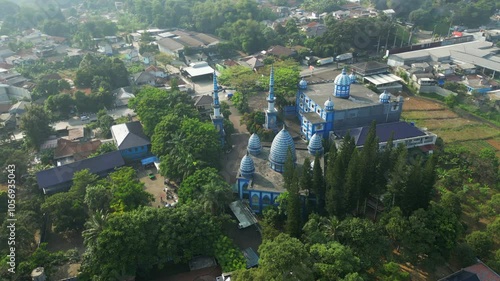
(296, 67, 404, 140)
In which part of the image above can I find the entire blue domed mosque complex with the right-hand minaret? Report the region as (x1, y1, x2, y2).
(236, 68, 437, 213)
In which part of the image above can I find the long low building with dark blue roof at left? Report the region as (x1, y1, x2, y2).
(36, 151, 125, 194)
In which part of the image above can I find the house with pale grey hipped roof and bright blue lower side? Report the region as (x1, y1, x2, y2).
(111, 121, 151, 160)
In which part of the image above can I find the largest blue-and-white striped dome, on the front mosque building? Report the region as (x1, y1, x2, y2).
(269, 128, 297, 172)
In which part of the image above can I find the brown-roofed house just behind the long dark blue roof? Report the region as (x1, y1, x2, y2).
(54, 138, 101, 166)
